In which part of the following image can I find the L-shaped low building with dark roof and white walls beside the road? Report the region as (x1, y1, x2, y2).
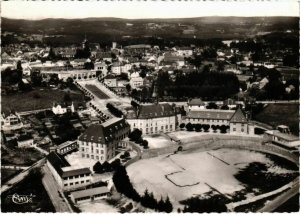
(47, 152, 92, 191)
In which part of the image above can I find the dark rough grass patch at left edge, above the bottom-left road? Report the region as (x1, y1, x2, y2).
(1, 147, 44, 166)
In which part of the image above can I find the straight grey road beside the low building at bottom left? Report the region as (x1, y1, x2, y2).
(42, 165, 73, 213)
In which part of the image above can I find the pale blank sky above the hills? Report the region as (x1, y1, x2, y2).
(1, 0, 299, 19)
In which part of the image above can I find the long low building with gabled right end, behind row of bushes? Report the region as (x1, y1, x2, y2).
(185, 108, 253, 134)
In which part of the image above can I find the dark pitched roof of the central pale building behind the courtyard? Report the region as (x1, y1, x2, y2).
(127, 103, 175, 119)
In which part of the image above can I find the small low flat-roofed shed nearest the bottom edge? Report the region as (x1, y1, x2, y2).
(70, 186, 110, 204)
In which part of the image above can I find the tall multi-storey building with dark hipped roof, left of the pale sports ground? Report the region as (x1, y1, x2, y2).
(78, 118, 130, 163)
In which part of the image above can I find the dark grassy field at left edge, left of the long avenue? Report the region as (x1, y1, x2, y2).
(1, 88, 84, 112)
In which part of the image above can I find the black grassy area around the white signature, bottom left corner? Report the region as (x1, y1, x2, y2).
(1, 171, 55, 213)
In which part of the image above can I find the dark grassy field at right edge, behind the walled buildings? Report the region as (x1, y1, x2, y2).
(254, 104, 299, 136)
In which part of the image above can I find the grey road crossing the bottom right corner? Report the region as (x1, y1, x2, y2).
(258, 179, 299, 212)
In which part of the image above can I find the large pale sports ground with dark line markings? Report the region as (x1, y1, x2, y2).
(127, 149, 296, 209)
